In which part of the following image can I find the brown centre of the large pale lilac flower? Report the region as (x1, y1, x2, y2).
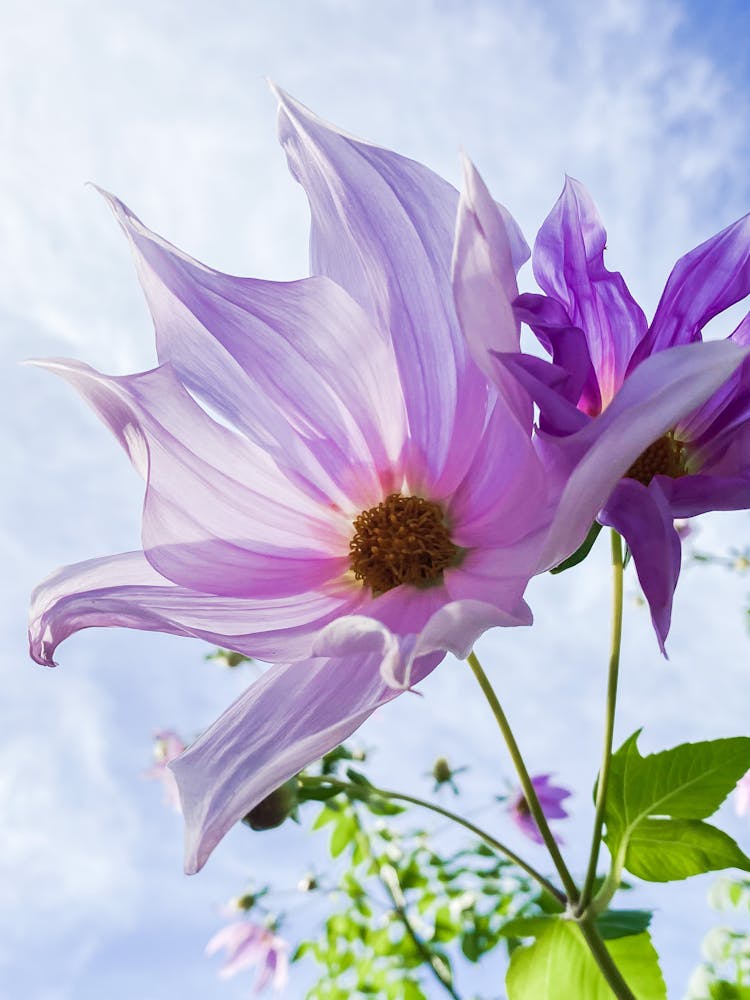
(349, 493, 461, 595)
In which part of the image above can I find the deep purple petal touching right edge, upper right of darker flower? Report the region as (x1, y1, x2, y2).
(633, 214, 750, 364)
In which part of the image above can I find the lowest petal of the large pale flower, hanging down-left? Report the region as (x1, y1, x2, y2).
(170, 654, 442, 874)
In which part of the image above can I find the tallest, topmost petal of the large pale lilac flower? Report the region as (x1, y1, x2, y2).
(276, 90, 487, 481)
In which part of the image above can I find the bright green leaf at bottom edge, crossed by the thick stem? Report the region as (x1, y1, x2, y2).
(505, 919, 667, 1000)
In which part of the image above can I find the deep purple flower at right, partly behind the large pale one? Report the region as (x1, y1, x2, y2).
(458, 166, 750, 651)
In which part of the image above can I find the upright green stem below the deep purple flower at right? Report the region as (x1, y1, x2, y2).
(578, 529, 623, 913)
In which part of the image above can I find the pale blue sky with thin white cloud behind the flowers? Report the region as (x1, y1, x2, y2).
(0, 0, 750, 1000)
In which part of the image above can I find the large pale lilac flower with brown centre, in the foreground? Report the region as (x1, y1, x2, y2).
(30, 95, 556, 871)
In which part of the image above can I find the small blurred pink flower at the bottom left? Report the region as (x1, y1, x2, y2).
(206, 920, 289, 993)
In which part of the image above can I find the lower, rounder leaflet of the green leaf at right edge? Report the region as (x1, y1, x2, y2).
(625, 819, 750, 882)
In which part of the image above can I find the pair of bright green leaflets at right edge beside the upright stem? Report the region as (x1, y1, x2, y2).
(605, 733, 750, 882)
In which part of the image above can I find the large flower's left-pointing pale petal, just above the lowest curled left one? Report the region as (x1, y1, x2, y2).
(33, 361, 351, 598)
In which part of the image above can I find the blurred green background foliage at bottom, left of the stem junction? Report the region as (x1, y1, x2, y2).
(294, 748, 548, 1000)
